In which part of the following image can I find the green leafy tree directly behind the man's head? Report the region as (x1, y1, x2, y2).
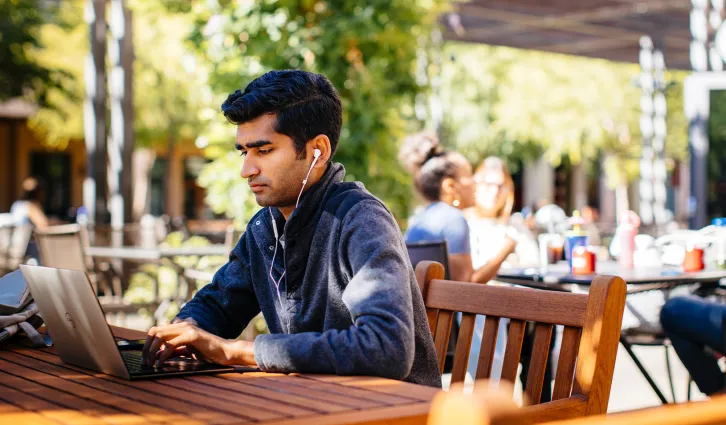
(183, 0, 444, 224)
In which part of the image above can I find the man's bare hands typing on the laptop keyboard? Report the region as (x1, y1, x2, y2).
(142, 320, 257, 366)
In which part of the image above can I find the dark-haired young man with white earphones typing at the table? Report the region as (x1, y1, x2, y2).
(144, 71, 441, 387)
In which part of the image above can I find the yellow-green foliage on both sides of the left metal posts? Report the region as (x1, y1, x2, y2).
(28, 0, 205, 147)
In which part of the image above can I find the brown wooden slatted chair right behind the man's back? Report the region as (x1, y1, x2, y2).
(416, 262, 626, 422)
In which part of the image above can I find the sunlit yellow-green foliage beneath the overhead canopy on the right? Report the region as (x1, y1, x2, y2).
(440, 43, 687, 187)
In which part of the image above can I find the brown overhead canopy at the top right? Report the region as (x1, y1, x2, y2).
(442, 0, 691, 69)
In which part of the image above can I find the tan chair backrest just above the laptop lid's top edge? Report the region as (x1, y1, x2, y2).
(35, 224, 93, 272)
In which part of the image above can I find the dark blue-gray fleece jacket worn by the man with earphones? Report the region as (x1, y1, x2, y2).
(178, 164, 441, 387)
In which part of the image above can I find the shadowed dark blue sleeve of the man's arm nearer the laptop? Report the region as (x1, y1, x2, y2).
(177, 232, 260, 339)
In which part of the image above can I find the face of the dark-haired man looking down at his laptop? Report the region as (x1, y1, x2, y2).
(235, 115, 309, 208)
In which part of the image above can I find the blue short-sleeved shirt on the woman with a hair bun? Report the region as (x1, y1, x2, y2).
(406, 202, 471, 254)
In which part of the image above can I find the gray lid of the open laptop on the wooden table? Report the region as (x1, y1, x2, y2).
(20, 265, 129, 379)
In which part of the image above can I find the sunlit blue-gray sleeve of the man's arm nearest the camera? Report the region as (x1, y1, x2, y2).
(255, 200, 415, 379)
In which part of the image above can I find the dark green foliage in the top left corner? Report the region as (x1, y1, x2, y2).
(0, 0, 74, 111)
